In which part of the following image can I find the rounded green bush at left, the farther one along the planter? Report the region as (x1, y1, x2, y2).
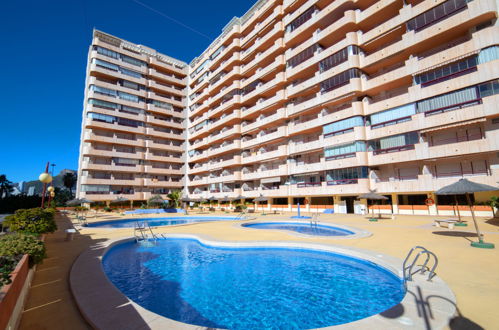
(6, 207, 57, 234)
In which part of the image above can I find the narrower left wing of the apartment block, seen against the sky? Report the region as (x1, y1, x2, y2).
(77, 30, 188, 202)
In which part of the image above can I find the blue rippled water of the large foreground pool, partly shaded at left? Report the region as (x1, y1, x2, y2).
(103, 238, 405, 330)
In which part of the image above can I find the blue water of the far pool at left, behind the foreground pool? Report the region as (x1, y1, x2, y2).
(87, 217, 238, 228)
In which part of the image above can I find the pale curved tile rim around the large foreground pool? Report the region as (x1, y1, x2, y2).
(70, 235, 456, 329)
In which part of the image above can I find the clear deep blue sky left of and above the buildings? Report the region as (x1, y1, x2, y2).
(0, 0, 255, 182)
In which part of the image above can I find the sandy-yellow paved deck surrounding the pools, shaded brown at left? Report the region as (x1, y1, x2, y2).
(20, 212, 499, 329)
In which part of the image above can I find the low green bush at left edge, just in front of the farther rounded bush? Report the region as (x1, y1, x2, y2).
(0, 233, 47, 266)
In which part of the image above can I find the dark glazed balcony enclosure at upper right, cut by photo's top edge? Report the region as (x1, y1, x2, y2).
(407, 0, 471, 32)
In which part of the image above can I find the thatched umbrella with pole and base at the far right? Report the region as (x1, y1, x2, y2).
(435, 179, 499, 249)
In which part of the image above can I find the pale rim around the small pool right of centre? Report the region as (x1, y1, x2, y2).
(240, 220, 372, 239)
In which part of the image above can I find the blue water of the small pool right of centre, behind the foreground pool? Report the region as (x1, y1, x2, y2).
(242, 222, 354, 236)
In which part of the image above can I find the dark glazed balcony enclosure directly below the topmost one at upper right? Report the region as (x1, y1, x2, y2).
(414, 55, 480, 87)
